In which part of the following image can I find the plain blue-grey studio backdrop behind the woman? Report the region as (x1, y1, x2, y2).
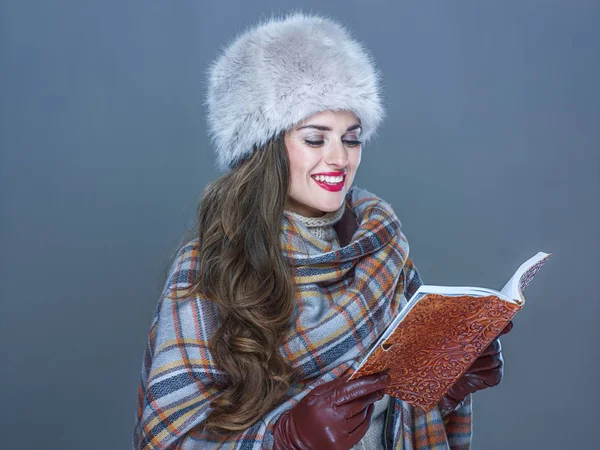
(0, 0, 600, 450)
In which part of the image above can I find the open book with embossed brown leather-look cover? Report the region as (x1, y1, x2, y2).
(350, 252, 552, 411)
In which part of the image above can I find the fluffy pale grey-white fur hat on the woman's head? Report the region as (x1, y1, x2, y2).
(206, 13, 384, 171)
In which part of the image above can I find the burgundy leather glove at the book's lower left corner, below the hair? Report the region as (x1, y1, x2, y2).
(273, 373, 390, 450)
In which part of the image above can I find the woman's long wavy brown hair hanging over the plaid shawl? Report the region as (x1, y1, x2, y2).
(172, 134, 294, 434)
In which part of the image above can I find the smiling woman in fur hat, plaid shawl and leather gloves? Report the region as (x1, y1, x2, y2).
(134, 13, 510, 450)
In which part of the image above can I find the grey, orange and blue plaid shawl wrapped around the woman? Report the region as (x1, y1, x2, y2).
(134, 187, 471, 450)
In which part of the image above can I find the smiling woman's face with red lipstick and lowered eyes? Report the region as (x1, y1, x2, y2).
(284, 111, 362, 217)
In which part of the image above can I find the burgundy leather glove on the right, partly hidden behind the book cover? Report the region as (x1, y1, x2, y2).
(438, 321, 513, 413)
